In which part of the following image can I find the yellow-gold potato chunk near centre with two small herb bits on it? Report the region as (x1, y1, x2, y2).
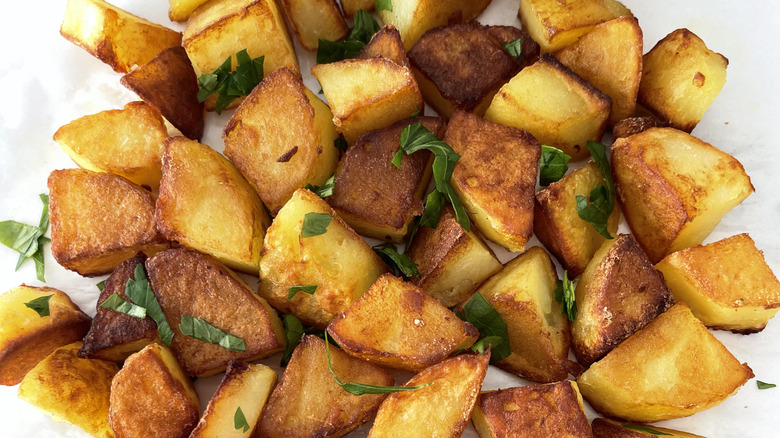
(257, 189, 387, 329)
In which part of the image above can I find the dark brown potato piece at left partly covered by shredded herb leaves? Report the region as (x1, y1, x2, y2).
(79, 253, 158, 363)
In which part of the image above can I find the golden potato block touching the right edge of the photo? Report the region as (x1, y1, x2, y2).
(656, 234, 780, 333)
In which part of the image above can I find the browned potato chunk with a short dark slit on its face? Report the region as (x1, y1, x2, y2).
(222, 67, 339, 215)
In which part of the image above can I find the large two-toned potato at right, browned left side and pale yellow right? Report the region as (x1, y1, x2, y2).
(612, 128, 754, 263)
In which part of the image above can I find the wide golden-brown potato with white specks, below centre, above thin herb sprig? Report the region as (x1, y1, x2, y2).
(328, 274, 479, 372)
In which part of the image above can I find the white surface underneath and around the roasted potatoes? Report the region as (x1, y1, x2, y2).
(0, 0, 780, 438)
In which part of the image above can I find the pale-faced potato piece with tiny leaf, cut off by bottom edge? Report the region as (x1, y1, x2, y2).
(190, 360, 276, 438)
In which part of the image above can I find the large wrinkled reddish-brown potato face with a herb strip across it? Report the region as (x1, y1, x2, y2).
(146, 248, 284, 377)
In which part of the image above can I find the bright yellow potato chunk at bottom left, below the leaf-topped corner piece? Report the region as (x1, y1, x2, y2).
(19, 342, 119, 438)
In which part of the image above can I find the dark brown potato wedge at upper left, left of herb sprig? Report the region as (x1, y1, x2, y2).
(120, 46, 205, 140)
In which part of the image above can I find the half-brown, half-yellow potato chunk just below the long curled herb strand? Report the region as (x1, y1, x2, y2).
(407, 206, 501, 307)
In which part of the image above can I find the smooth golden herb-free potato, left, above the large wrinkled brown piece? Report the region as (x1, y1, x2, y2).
(155, 137, 270, 275)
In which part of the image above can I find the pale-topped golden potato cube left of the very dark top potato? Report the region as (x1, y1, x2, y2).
(311, 58, 423, 144)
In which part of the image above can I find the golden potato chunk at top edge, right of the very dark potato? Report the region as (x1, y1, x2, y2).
(517, 0, 633, 53)
